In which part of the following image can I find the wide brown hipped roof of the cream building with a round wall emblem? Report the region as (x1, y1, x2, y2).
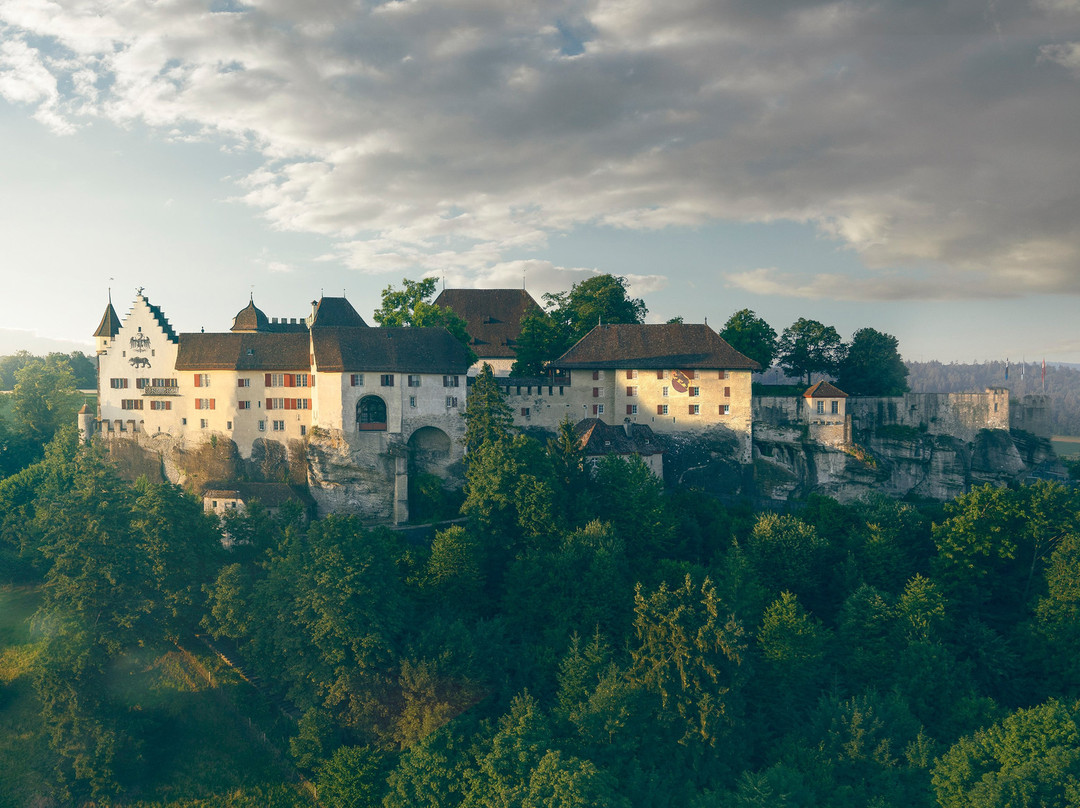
(554, 323, 761, 371)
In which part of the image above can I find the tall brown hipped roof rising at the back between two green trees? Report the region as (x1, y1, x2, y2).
(435, 289, 542, 359)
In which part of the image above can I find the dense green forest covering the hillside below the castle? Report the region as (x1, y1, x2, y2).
(0, 373, 1080, 808)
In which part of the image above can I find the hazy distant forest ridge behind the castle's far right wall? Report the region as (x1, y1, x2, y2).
(906, 361, 1080, 435)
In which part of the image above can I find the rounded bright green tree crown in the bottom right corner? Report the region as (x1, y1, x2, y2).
(933, 699, 1080, 808)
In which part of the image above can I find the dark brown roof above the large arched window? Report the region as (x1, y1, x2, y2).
(311, 327, 469, 374)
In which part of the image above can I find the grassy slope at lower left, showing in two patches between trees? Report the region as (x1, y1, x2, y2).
(0, 587, 310, 808)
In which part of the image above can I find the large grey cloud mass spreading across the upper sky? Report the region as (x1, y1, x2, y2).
(6, 0, 1080, 299)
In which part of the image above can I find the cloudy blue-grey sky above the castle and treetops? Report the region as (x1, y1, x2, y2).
(0, 0, 1080, 362)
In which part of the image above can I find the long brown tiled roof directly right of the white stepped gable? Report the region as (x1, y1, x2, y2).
(176, 333, 311, 371)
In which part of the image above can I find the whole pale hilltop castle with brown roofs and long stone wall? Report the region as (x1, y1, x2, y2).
(86, 288, 1044, 523)
